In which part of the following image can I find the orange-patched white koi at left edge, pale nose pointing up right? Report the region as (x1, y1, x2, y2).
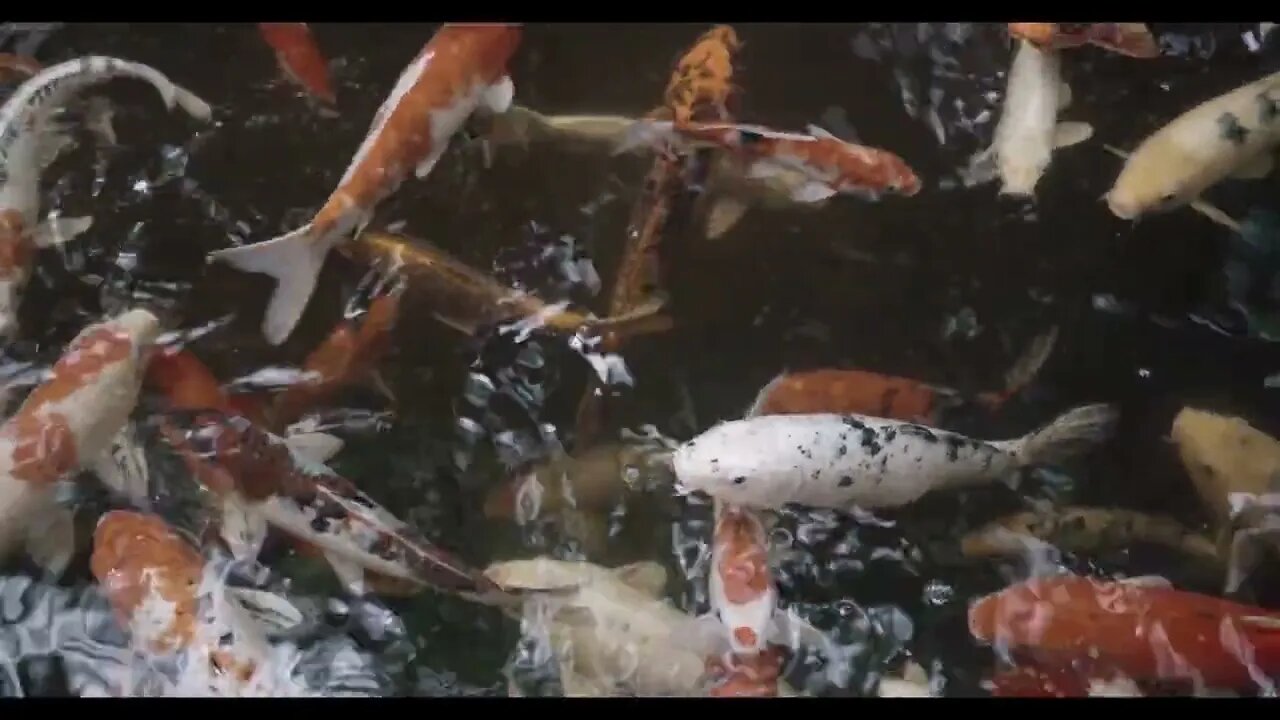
(0, 310, 160, 573)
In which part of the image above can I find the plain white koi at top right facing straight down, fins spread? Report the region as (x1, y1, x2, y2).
(965, 40, 1093, 197)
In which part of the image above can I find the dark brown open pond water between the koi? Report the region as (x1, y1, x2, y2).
(2, 23, 1280, 694)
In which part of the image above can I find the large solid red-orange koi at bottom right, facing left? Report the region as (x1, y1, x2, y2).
(969, 575, 1280, 688)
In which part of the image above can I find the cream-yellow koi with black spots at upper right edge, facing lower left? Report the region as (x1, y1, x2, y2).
(1106, 72, 1280, 220)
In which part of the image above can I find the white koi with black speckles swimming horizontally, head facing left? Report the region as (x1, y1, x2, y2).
(672, 405, 1116, 510)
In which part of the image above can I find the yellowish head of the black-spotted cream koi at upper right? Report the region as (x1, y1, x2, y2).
(1105, 136, 1206, 220)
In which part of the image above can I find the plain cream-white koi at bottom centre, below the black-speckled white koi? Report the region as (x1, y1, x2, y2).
(485, 557, 708, 696)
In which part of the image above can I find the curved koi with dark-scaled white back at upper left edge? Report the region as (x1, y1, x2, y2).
(0, 56, 212, 337)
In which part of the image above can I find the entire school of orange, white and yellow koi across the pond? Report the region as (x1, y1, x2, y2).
(0, 23, 1280, 697)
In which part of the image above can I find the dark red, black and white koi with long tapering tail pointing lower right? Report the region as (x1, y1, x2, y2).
(163, 411, 512, 606)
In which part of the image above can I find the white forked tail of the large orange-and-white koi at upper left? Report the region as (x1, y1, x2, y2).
(209, 223, 334, 345)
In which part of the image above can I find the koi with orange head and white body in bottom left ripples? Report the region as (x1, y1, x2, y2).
(90, 510, 350, 697)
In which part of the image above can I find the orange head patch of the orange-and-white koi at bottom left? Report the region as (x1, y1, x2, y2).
(90, 510, 204, 652)
